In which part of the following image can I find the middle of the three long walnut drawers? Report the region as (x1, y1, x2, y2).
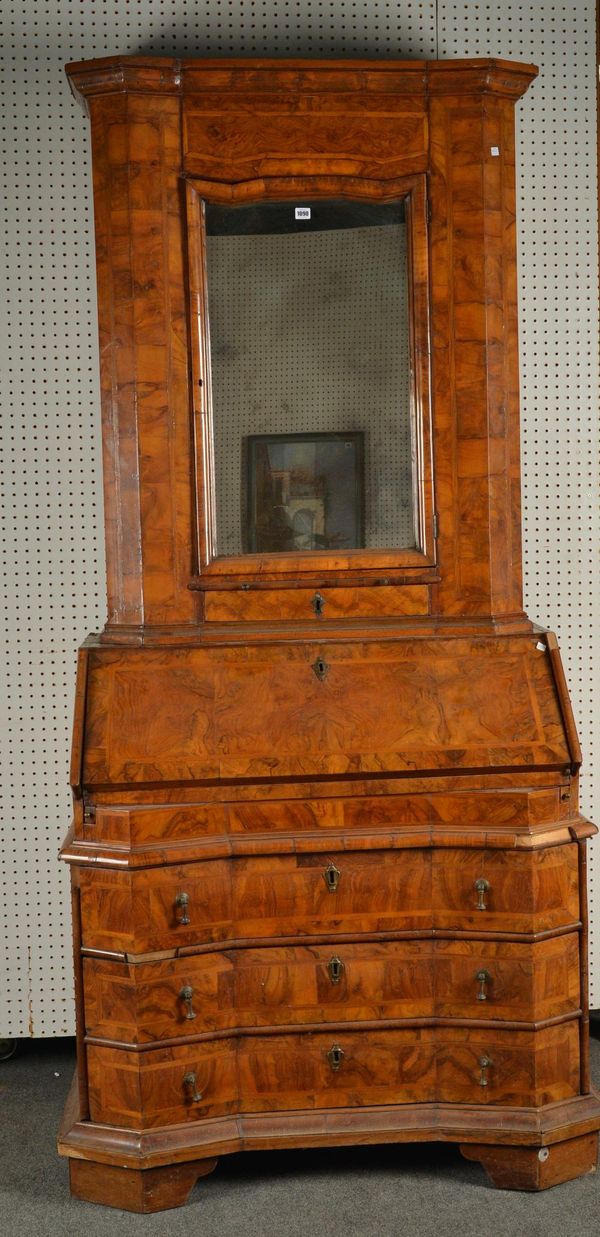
(84, 933, 580, 1044)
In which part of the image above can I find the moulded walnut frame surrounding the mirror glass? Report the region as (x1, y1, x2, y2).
(186, 174, 435, 589)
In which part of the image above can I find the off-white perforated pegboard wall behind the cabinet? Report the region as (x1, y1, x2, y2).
(0, 0, 600, 1035)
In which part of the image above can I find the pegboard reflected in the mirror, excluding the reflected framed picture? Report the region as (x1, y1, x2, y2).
(207, 220, 414, 554)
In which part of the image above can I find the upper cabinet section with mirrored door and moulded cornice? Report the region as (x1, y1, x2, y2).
(67, 57, 536, 638)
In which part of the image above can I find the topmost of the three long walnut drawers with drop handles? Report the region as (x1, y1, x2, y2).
(80, 844, 579, 954)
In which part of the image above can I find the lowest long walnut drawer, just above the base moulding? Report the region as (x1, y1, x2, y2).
(87, 1022, 579, 1129)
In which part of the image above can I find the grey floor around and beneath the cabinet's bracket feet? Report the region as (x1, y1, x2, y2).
(0, 1027, 600, 1237)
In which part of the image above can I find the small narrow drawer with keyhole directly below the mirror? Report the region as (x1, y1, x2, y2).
(204, 584, 429, 622)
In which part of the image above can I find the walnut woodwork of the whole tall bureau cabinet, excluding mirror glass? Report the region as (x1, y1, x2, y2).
(59, 57, 600, 1211)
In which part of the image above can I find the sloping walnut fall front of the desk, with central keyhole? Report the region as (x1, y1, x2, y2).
(83, 637, 570, 785)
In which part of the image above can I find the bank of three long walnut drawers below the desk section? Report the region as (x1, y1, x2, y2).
(79, 839, 581, 1129)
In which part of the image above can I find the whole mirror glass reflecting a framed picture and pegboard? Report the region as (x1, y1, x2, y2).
(205, 200, 416, 554)
